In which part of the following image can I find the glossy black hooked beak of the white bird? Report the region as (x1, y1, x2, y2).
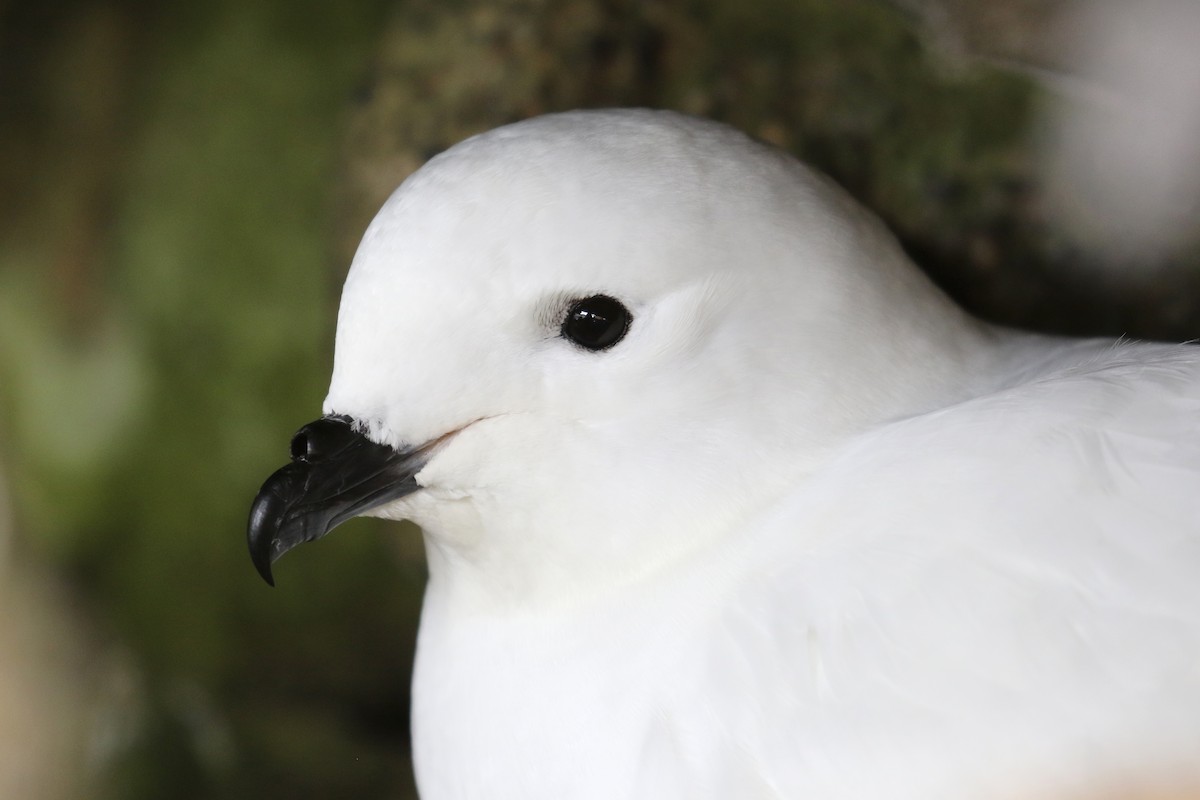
(246, 416, 428, 587)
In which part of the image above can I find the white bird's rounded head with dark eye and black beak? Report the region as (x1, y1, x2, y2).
(250, 110, 984, 604)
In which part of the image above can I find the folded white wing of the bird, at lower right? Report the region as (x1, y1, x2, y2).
(657, 345, 1200, 799)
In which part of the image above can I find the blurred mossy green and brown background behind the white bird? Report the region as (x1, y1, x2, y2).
(0, 0, 1200, 800)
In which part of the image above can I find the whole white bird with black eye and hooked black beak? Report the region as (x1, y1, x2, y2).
(250, 110, 1200, 800)
